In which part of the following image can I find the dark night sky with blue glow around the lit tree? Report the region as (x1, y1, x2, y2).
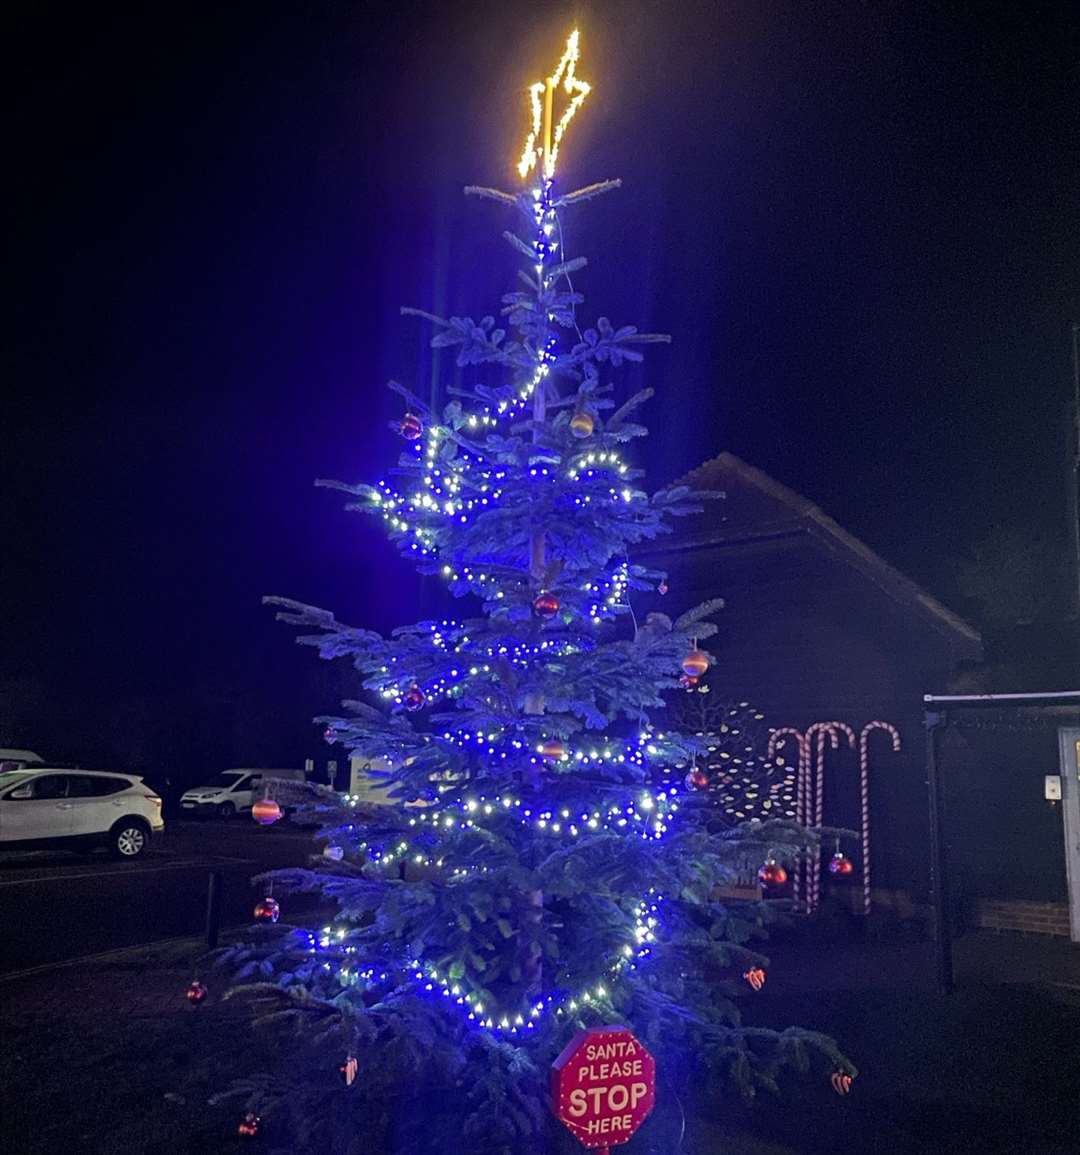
(8, 0, 1080, 775)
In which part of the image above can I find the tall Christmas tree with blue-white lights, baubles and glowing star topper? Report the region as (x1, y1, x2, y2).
(228, 32, 851, 1152)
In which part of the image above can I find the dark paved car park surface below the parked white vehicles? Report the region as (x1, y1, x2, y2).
(0, 818, 313, 974)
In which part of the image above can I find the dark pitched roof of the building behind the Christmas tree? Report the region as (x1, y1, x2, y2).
(641, 453, 982, 643)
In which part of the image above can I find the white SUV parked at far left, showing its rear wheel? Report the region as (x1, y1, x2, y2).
(0, 767, 165, 858)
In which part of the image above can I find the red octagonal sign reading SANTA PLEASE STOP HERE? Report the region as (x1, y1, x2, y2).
(551, 1027, 656, 1152)
